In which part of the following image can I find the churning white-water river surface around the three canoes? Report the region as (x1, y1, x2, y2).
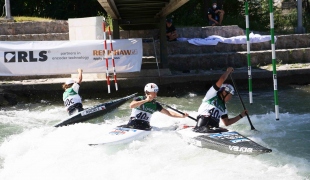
(0, 86, 310, 180)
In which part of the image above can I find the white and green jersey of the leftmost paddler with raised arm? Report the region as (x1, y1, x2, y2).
(62, 83, 82, 109)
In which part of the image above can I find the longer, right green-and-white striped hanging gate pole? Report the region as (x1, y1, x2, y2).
(269, 0, 279, 120)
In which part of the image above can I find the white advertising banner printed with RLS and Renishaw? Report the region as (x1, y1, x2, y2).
(0, 38, 143, 76)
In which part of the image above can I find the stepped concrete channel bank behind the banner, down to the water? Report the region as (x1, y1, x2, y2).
(0, 21, 310, 106)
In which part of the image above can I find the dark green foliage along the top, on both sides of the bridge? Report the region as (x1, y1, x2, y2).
(0, 0, 310, 33)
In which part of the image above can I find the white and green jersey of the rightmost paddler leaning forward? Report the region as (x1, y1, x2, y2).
(198, 85, 227, 122)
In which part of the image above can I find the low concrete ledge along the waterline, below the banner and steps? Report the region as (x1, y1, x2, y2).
(0, 67, 310, 91)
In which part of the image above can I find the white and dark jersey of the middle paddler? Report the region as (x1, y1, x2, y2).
(130, 96, 163, 122)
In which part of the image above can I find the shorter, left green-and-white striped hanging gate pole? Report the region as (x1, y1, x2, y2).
(245, 1, 253, 104)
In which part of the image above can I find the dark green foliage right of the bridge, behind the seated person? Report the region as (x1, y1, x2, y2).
(168, 0, 310, 33)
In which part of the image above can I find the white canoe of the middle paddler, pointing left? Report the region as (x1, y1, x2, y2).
(89, 127, 151, 146)
